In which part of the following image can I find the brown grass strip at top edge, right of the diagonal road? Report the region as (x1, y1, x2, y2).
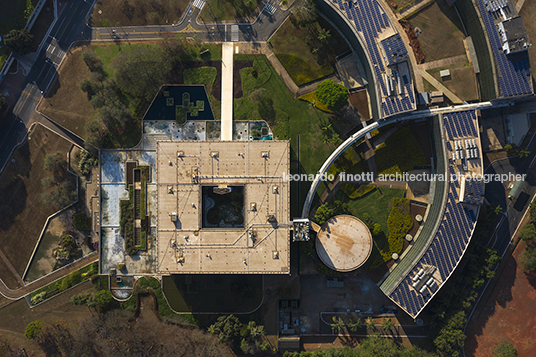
(93, 0, 189, 27)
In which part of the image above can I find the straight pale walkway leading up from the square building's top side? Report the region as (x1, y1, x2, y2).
(221, 42, 234, 141)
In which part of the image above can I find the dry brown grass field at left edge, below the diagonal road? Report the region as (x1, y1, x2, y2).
(0, 125, 74, 288)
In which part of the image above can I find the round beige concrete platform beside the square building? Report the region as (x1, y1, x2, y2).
(316, 215, 372, 272)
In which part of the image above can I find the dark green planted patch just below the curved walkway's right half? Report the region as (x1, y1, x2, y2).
(374, 127, 426, 175)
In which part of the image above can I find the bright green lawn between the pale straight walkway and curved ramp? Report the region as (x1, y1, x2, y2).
(234, 55, 340, 214)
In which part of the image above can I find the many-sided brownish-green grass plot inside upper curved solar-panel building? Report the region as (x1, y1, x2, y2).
(270, 18, 349, 86)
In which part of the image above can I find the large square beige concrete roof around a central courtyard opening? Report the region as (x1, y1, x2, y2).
(156, 141, 292, 274)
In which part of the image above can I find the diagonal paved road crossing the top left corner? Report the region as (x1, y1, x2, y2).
(0, 1, 92, 170)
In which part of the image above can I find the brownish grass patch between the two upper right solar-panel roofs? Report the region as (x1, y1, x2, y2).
(408, 1, 465, 62)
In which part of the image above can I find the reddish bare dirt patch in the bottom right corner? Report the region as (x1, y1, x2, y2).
(465, 242, 536, 357)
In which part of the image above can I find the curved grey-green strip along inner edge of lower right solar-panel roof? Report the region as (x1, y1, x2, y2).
(380, 117, 448, 296)
